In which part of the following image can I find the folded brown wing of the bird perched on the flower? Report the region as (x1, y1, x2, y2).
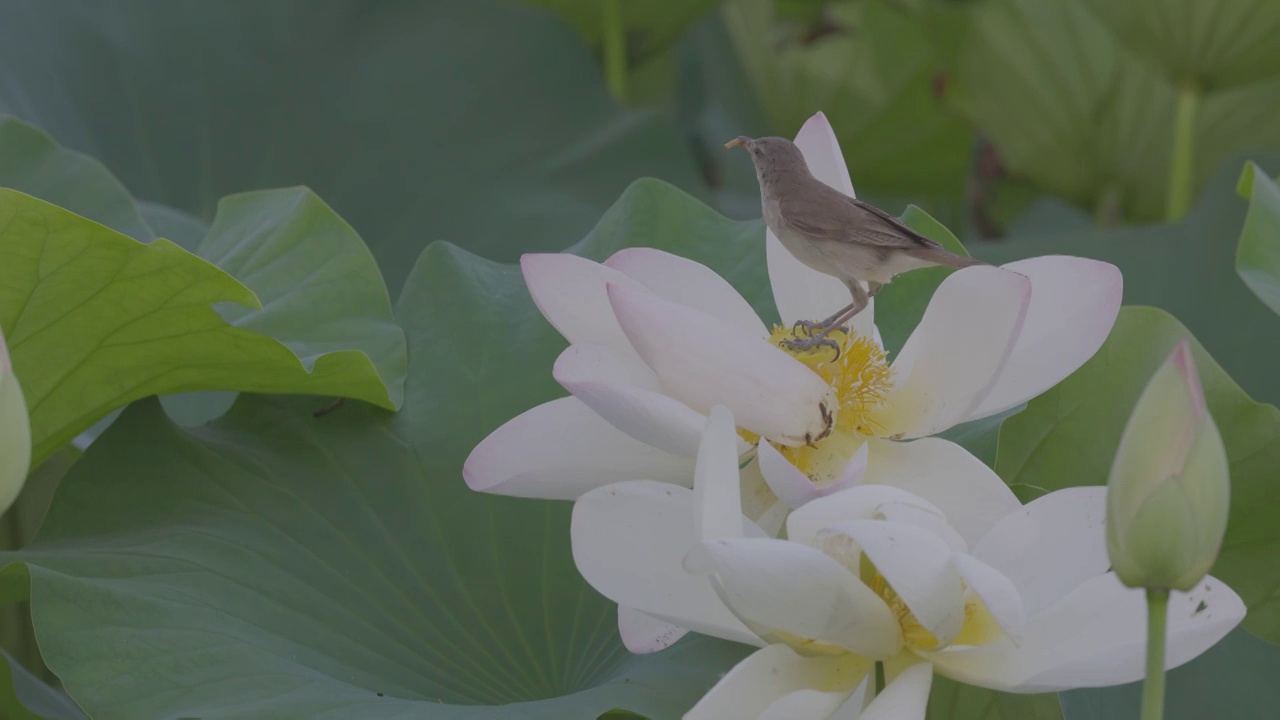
(778, 182, 941, 249)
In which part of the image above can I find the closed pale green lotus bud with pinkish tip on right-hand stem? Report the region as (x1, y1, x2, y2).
(1107, 340, 1231, 591)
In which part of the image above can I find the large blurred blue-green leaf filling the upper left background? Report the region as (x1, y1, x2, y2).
(0, 0, 699, 292)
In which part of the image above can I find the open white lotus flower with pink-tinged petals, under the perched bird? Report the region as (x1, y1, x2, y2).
(463, 114, 1121, 509)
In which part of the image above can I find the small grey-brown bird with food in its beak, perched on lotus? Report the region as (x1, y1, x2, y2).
(724, 135, 988, 357)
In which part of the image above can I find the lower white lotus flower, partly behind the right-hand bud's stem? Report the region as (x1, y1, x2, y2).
(572, 407, 1244, 720)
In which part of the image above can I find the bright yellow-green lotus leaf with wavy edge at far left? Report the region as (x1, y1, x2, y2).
(0, 190, 403, 465)
